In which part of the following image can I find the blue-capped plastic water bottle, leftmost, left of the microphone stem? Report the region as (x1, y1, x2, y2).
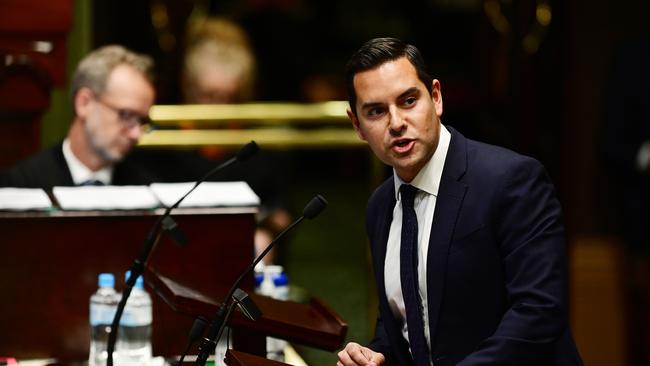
(88, 273, 120, 366)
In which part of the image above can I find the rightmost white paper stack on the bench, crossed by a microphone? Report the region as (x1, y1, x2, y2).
(150, 182, 260, 207)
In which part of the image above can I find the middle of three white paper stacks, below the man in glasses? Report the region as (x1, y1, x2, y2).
(52, 186, 160, 210)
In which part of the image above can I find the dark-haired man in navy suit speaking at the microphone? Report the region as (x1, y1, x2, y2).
(338, 38, 582, 366)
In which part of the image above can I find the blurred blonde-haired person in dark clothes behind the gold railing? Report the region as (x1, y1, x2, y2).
(181, 17, 291, 264)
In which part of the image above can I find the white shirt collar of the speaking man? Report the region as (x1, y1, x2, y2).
(393, 124, 451, 200)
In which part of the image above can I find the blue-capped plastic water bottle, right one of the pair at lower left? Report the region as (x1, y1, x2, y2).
(116, 272, 152, 366)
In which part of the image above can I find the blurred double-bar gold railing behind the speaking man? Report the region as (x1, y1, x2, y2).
(139, 101, 365, 149)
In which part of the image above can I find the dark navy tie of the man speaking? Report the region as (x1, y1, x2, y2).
(400, 184, 431, 366)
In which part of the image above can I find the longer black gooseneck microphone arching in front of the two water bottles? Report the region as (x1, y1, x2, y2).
(107, 141, 259, 366)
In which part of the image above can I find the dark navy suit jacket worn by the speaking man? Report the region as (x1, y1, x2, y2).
(367, 127, 582, 366)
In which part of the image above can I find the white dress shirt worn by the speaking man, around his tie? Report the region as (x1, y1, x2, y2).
(384, 125, 451, 358)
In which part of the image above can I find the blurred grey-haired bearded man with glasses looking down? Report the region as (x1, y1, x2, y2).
(0, 46, 155, 189)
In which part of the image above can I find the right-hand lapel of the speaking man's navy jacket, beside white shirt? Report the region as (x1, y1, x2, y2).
(427, 127, 467, 346)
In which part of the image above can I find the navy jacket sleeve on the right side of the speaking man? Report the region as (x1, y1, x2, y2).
(459, 156, 568, 366)
